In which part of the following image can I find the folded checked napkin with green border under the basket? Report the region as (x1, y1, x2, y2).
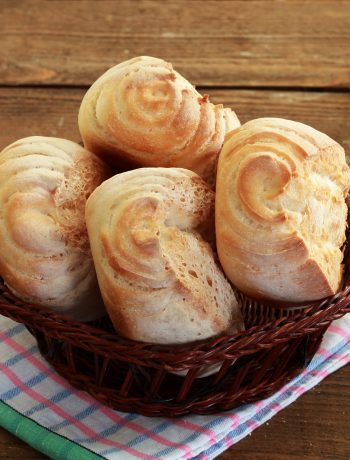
(0, 314, 350, 460)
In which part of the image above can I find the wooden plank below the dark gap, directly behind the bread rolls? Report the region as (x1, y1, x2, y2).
(0, 88, 350, 158)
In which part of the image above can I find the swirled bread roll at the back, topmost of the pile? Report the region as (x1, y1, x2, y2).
(79, 56, 240, 185)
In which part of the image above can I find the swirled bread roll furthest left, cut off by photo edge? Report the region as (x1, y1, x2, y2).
(0, 137, 110, 321)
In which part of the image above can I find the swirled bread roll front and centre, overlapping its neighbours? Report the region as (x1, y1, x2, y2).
(86, 168, 242, 344)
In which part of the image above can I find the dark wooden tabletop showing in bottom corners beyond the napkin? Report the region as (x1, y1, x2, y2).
(0, 366, 350, 460)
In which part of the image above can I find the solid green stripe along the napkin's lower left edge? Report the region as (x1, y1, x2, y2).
(0, 401, 103, 460)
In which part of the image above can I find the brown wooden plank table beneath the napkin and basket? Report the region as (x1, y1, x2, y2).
(0, 0, 350, 460)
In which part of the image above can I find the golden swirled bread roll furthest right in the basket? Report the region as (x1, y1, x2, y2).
(216, 118, 350, 302)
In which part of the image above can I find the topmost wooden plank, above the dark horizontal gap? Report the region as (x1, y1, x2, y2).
(0, 0, 350, 88)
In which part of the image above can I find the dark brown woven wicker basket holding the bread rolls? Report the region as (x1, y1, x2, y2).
(0, 241, 350, 417)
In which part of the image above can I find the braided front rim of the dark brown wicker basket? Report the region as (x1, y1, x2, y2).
(0, 279, 350, 365)
